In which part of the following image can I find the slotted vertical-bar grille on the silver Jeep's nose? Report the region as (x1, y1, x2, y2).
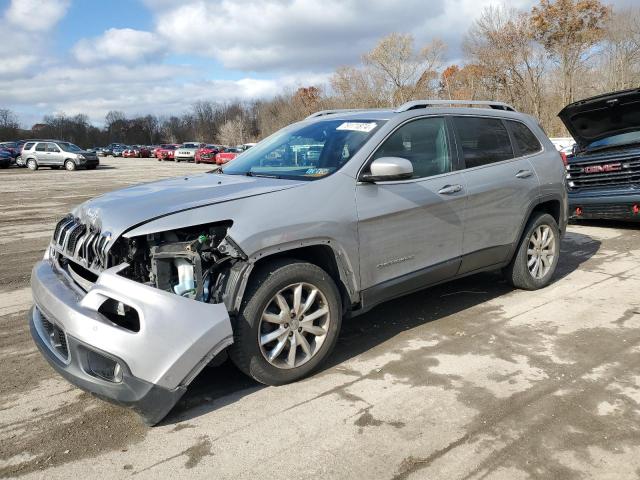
(53, 215, 111, 271)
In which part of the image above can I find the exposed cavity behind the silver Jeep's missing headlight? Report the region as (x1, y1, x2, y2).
(109, 222, 244, 303)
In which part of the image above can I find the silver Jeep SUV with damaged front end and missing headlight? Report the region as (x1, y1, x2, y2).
(29, 101, 567, 424)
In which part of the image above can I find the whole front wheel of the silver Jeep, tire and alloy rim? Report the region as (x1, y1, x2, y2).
(229, 259, 342, 385)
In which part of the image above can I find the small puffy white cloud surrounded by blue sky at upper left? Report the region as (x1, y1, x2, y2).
(73, 28, 165, 63)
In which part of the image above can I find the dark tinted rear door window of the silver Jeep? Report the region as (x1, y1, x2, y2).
(453, 117, 514, 168)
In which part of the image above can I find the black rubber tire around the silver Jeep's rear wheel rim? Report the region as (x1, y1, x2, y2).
(503, 212, 560, 290)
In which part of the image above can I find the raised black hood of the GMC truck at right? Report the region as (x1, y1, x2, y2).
(558, 89, 640, 150)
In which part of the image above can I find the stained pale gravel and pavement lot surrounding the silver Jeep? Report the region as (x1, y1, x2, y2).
(0, 159, 640, 480)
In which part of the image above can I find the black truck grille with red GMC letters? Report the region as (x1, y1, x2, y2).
(567, 156, 640, 191)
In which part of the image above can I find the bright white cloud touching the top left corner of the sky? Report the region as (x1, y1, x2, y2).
(5, 0, 70, 32)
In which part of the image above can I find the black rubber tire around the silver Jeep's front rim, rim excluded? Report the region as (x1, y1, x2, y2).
(229, 259, 342, 385)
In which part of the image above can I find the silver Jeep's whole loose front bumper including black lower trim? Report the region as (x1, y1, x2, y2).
(29, 260, 233, 424)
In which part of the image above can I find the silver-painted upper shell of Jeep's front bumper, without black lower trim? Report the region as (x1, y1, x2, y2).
(31, 260, 233, 389)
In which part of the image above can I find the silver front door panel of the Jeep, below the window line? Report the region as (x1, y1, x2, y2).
(356, 172, 467, 289)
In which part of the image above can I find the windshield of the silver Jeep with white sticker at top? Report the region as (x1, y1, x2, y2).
(223, 120, 385, 180)
